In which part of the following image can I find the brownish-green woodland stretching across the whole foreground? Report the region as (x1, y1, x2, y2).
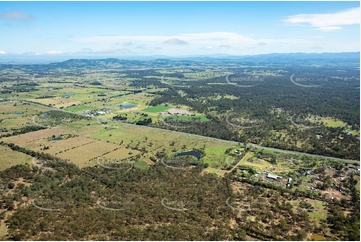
(0, 155, 359, 240)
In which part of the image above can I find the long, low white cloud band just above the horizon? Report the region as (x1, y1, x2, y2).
(69, 32, 316, 54)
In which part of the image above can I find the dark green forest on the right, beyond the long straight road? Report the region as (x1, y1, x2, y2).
(141, 68, 360, 160)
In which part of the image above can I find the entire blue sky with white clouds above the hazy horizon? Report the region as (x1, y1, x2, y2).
(0, 2, 360, 57)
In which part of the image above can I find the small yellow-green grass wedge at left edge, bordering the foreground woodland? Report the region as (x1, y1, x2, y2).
(0, 146, 32, 170)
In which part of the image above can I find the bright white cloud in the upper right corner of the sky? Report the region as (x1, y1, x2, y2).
(284, 8, 360, 32)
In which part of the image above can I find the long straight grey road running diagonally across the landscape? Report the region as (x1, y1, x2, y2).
(20, 100, 360, 164)
